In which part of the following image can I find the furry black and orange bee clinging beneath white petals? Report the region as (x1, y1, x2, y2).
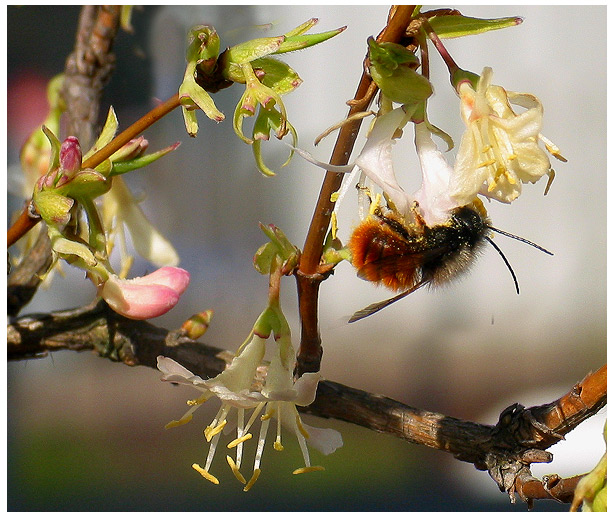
(348, 201, 553, 322)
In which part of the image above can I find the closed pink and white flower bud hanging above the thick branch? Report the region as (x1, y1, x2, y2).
(100, 266, 190, 320)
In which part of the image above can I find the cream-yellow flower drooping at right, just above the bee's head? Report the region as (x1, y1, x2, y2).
(450, 67, 562, 205)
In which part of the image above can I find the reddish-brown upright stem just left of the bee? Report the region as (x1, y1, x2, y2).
(296, 5, 422, 374)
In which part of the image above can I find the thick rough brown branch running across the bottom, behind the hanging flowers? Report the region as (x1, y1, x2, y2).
(7, 302, 607, 505)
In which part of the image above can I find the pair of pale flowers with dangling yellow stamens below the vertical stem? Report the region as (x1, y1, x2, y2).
(158, 308, 342, 491)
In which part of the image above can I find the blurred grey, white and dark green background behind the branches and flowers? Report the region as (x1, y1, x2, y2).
(7, 5, 606, 511)
